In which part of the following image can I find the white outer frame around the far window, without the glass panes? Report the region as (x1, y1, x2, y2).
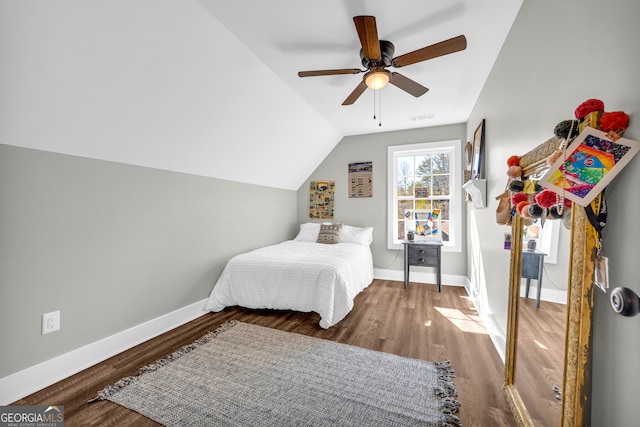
(387, 139, 462, 252)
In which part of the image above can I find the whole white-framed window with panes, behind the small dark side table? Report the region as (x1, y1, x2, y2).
(387, 140, 461, 252)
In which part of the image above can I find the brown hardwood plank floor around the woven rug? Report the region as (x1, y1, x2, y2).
(15, 280, 515, 427)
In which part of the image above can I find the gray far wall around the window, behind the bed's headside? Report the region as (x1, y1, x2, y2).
(298, 124, 466, 276)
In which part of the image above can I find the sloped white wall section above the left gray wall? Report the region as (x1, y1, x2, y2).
(0, 0, 341, 190)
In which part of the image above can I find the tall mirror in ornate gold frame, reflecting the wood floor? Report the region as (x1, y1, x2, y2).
(504, 138, 595, 426)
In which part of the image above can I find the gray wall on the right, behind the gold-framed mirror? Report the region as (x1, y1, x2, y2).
(467, 0, 640, 426)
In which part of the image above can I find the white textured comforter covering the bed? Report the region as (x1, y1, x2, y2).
(206, 240, 373, 329)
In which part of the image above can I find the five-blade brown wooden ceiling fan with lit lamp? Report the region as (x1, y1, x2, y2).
(298, 16, 467, 105)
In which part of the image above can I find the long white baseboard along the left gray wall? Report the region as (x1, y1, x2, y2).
(0, 299, 207, 405)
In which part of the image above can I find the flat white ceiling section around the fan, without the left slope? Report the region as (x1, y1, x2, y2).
(199, 0, 522, 135)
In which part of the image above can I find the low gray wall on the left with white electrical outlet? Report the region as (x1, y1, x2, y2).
(0, 145, 297, 378)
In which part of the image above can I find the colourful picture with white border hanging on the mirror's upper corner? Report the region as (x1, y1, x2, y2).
(538, 126, 640, 207)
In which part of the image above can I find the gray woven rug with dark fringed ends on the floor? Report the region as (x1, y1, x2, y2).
(94, 321, 460, 427)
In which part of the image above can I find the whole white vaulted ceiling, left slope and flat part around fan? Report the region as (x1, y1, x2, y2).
(0, 0, 525, 189)
